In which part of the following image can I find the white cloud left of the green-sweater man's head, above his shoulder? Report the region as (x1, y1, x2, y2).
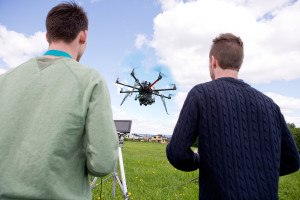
(0, 25, 48, 68)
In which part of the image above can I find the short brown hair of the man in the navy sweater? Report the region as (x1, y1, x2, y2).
(209, 33, 244, 70)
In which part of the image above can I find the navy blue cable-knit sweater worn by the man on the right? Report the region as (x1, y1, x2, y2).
(167, 78, 299, 200)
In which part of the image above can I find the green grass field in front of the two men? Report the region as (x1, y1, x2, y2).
(93, 141, 300, 200)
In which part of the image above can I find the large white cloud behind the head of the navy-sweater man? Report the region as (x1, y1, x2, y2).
(151, 0, 300, 91)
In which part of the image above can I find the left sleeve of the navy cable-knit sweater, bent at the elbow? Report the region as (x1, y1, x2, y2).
(166, 90, 199, 171)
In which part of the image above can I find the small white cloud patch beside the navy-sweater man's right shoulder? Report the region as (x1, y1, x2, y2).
(265, 92, 300, 127)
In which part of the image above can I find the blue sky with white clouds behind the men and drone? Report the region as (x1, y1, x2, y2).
(0, 0, 300, 135)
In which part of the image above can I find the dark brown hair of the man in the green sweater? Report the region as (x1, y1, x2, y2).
(46, 1, 88, 43)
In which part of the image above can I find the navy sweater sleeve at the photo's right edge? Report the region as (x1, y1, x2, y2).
(280, 114, 300, 176)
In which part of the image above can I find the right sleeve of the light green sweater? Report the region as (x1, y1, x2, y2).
(85, 74, 118, 177)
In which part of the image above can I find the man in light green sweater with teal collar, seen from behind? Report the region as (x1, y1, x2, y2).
(0, 2, 118, 200)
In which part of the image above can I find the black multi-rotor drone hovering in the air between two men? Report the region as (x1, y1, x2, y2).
(116, 69, 177, 114)
